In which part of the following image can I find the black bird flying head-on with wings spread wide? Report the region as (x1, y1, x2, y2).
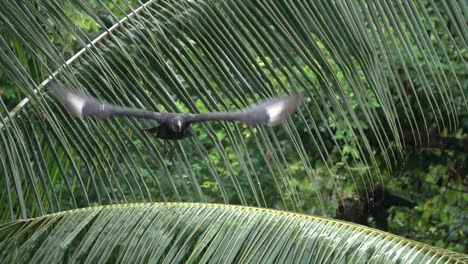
(49, 82, 303, 143)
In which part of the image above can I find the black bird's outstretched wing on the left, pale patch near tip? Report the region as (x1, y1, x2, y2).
(49, 82, 180, 122)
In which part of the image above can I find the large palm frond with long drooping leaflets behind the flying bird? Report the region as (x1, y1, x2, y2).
(0, 0, 468, 220)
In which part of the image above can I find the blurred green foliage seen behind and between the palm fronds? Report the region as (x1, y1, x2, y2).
(0, 0, 468, 252)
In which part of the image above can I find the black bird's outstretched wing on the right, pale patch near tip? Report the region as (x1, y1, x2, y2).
(186, 93, 303, 126)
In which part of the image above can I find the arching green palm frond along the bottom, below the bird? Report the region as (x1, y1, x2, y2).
(0, 203, 468, 263)
